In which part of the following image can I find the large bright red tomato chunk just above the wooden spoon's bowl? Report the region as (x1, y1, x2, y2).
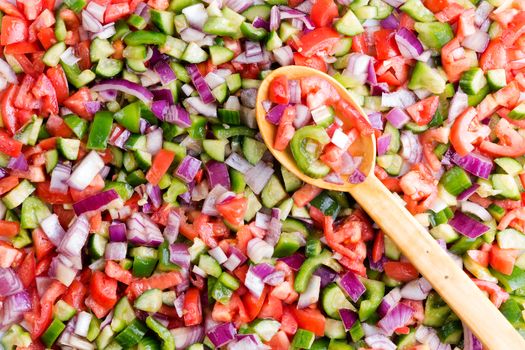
(297, 27, 341, 57)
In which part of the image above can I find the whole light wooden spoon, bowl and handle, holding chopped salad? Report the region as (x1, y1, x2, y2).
(256, 66, 525, 350)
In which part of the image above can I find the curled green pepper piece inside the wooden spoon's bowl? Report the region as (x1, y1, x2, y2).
(290, 125, 330, 179)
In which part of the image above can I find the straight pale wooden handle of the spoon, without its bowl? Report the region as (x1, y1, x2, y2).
(349, 175, 525, 350)
